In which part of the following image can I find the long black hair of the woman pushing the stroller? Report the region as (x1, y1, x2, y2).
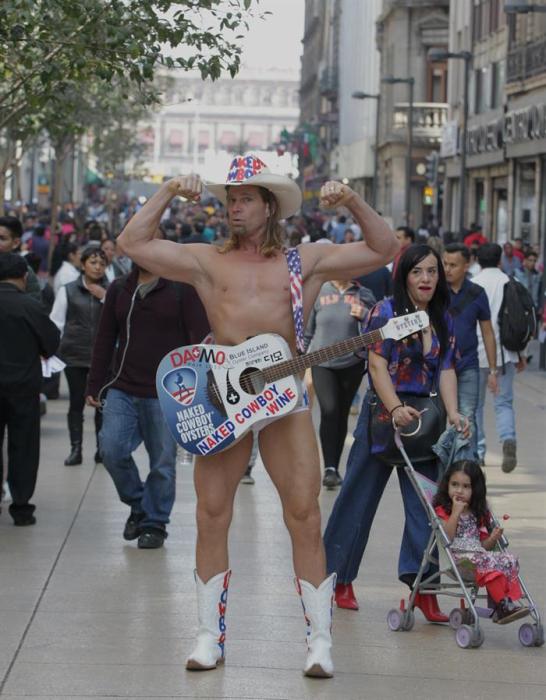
(393, 244, 449, 357)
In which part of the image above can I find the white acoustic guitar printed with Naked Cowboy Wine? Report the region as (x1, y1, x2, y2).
(156, 311, 429, 455)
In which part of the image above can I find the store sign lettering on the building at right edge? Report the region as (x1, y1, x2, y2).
(466, 104, 546, 156)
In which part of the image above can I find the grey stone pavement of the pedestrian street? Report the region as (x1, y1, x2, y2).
(0, 360, 546, 700)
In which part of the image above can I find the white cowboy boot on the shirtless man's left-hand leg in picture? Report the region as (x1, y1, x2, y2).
(186, 570, 231, 671)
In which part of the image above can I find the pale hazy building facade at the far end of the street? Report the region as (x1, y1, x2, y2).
(136, 68, 299, 181)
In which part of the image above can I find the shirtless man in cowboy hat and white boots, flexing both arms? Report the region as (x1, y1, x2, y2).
(118, 156, 399, 677)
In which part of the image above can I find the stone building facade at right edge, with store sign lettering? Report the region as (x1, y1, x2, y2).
(442, 0, 546, 250)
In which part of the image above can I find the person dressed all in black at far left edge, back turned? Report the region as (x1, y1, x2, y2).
(0, 253, 59, 525)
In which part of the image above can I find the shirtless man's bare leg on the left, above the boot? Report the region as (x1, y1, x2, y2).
(194, 434, 252, 583)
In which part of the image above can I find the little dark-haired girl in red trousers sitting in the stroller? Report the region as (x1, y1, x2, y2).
(434, 460, 529, 625)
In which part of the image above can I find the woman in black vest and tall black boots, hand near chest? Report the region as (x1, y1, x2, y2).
(50, 246, 107, 467)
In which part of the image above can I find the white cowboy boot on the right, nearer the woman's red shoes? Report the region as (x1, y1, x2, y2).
(295, 574, 336, 678)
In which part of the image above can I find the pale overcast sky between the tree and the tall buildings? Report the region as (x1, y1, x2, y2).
(237, 0, 305, 71)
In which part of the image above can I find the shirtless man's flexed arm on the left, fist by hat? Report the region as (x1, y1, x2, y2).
(117, 175, 202, 282)
